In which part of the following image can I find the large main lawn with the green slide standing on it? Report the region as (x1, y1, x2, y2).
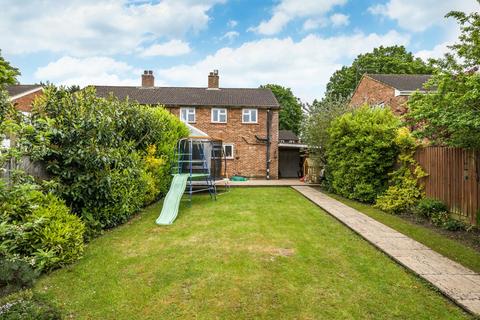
(35, 188, 468, 319)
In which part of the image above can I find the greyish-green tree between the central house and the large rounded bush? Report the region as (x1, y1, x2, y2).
(302, 97, 351, 165)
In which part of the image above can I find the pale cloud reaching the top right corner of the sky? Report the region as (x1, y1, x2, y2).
(368, 0, 480, 32)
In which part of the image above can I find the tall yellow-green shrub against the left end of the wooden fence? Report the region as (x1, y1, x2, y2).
(375, 128, 425, 213)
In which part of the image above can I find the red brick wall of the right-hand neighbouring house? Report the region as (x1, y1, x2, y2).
(350, 76, 408, 116)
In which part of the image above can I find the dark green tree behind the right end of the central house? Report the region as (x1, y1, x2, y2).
(261, 84, 303, 135)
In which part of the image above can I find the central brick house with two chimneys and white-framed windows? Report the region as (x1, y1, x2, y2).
(95, 70, 280, 179)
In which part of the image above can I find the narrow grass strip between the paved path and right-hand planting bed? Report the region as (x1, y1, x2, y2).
(322, 191, 480, 273)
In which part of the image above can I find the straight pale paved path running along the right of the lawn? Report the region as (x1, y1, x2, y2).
(293, 186, 480, 315)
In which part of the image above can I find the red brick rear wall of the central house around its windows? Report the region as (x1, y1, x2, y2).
(168, 107, 278, 179)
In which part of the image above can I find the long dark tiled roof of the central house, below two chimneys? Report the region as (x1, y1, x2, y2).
(94, 86, 279, 108)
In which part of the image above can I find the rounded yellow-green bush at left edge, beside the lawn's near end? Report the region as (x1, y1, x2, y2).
(0, 183, 85, 270)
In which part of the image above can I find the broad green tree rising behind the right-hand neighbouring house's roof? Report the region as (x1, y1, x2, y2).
(325, 46, 433, 98)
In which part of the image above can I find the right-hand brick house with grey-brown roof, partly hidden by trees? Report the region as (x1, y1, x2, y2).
(350, 74, 431, 116)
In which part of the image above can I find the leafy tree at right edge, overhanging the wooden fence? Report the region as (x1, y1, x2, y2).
(409, 5, 480, 150)
